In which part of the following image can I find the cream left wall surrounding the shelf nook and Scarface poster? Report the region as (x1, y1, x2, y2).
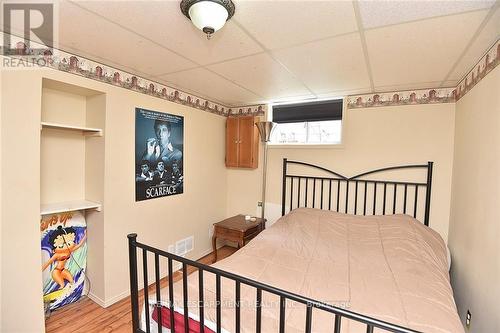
(0, 69, 226, 332)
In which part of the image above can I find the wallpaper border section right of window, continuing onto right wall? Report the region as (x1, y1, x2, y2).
(346, 40, 500, 109)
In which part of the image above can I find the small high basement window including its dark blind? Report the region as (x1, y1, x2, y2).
(270, 99, 343, 145)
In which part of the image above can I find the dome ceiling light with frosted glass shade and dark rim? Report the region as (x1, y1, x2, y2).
(181, 0, 235, 39)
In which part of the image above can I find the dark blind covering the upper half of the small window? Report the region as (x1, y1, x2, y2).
(273, 99, 343, 123)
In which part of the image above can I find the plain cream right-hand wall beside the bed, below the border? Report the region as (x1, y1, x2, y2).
(449, 67, 500, 333)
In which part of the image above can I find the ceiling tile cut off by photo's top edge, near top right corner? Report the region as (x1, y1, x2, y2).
(359, 0, 495, 29)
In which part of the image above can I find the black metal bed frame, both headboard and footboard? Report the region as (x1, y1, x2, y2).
(127, 158, 433, 333)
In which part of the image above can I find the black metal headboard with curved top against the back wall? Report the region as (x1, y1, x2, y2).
(281, 158, 433, 226)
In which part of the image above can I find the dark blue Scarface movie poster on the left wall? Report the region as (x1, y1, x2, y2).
(135, 108, 184, 201)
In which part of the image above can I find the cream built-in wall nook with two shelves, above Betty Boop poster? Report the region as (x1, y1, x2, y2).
(40, 79, 106, 215)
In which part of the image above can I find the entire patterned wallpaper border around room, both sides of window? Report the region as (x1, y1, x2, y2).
(1, 33, 500, 113)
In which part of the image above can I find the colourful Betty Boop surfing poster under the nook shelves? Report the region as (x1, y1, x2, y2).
(40, 212, 87, 310)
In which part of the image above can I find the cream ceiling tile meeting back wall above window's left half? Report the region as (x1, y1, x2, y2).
(208, 53, 311, 100)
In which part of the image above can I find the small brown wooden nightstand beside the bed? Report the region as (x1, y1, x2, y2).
(212, 215, 266, 262)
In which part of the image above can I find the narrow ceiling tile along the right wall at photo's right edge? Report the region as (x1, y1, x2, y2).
(449, 6, 500, 80)
